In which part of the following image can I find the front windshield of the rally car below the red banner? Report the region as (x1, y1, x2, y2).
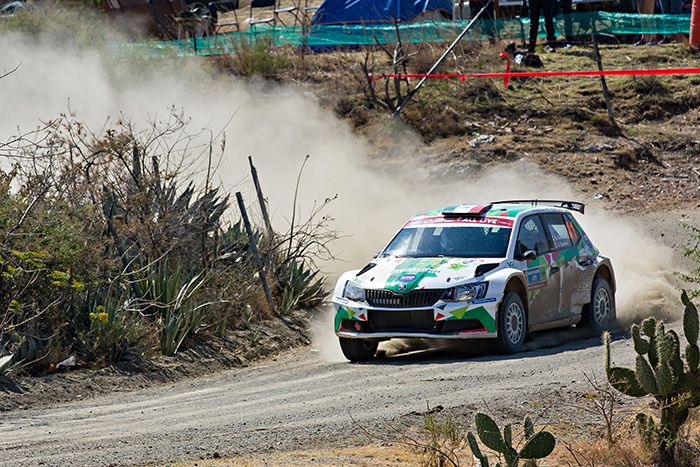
(382, 226, 511, 258)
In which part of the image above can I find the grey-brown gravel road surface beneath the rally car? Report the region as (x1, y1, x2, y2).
(0, 330, 644, 465)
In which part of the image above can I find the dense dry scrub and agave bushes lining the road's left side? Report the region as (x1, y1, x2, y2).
(0, 113, 334, 378)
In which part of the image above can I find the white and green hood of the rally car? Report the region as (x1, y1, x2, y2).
(354, 257, 504, 293)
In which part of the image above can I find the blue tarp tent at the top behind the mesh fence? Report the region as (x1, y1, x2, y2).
(312, 0, 452, 24)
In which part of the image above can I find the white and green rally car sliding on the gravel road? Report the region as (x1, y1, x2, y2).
(332, 200, 615, 361)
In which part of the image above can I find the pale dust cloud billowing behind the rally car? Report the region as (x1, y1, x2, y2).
(0, 25, 673, 359)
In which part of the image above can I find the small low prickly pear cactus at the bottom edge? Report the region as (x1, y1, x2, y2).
(467, 412, 556, 467)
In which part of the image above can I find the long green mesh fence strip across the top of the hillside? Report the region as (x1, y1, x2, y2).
(118, 12, 690, 56)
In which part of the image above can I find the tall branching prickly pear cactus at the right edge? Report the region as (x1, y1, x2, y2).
(603, 291, 700, 465)
